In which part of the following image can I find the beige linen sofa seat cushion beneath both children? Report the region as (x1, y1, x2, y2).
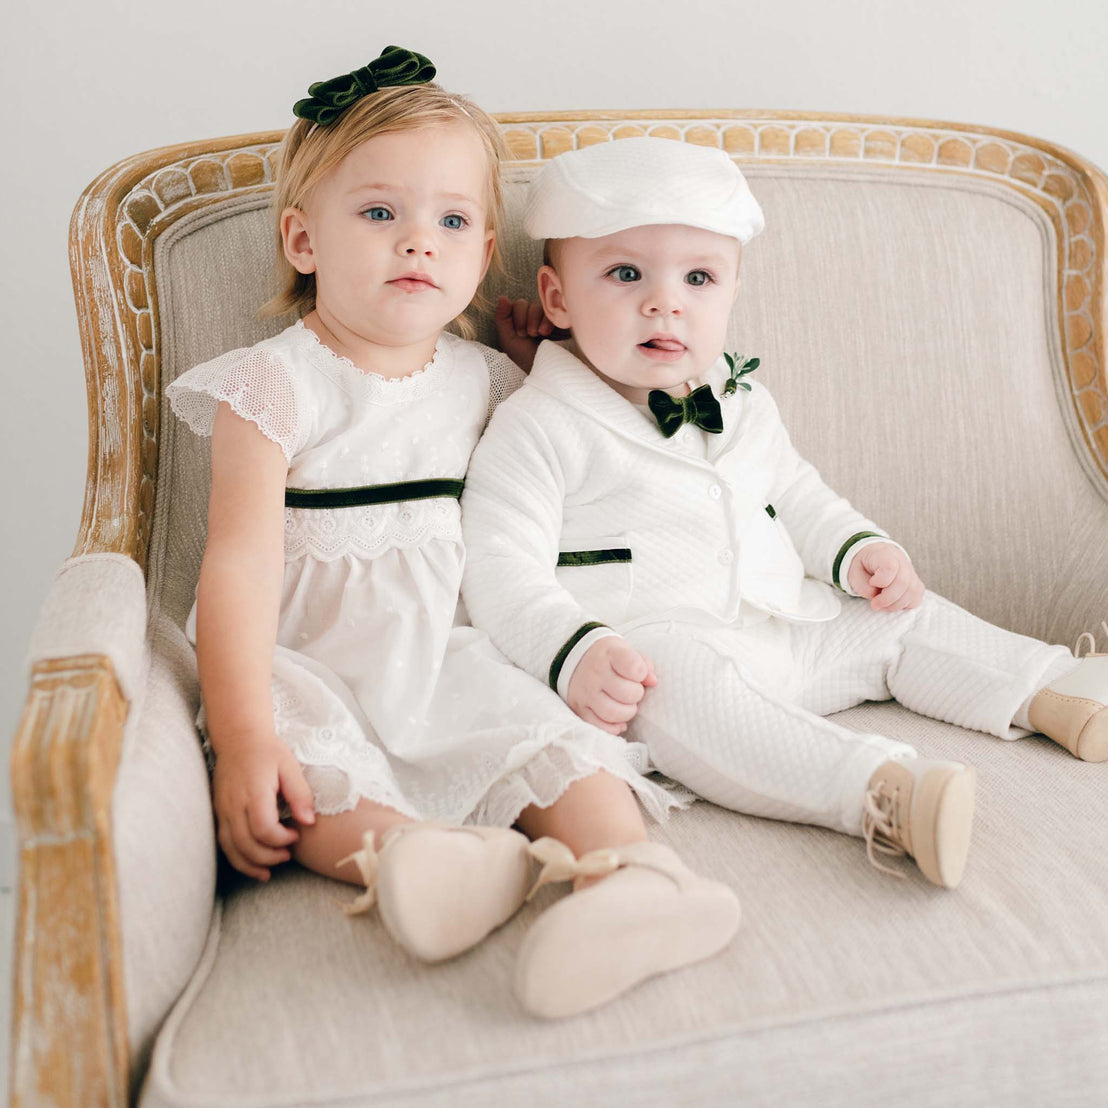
(141, 705, 1108, 1108)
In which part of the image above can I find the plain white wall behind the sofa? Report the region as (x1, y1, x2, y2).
(0, 0, 1108, 885)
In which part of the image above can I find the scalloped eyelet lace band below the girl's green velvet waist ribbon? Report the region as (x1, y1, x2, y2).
(285, 497, 462, 562)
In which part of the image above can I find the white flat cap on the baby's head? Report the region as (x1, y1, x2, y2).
(523, 137, 766, 243)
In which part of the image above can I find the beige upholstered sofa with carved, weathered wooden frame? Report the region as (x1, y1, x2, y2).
(11, 112, 1108, 1108)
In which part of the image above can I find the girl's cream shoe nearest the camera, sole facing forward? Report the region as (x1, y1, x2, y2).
(515, 839, 740, 1019)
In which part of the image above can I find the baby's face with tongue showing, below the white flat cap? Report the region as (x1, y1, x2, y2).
(538, 224, 740, 404)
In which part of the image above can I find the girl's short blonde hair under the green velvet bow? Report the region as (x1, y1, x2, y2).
(261, 83, 505, 338)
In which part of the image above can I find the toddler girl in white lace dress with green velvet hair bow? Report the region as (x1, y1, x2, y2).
(167, 47, 738, 1015)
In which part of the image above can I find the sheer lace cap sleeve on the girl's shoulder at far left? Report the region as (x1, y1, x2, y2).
(165, 347, 301, 461)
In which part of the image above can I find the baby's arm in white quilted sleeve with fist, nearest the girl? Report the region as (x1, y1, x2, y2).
(462, 398, 654, 735)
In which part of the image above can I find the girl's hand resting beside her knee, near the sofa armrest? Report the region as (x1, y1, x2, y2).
(212, 735, 316, 881)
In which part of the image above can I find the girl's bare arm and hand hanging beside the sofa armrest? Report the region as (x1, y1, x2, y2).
(196, 403, 315, 881)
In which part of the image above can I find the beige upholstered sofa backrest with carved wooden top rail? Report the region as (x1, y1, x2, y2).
(105, 115, 1108, 644)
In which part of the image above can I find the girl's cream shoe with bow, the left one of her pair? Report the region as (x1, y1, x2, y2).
(339, 822, 532, 962)
